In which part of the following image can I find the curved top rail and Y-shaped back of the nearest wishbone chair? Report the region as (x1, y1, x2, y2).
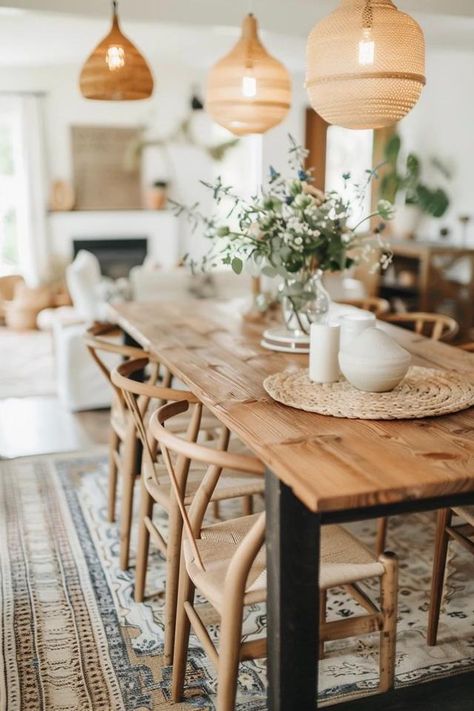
(150, 401, 264, 570)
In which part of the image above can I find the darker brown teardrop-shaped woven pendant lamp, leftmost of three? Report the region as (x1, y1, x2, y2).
(79, 0, 153, 101)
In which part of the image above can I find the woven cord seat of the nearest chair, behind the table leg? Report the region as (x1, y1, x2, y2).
(183, 514, 384, 612)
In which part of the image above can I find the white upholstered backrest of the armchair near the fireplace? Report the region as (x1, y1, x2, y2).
(66, 249, 102, 321)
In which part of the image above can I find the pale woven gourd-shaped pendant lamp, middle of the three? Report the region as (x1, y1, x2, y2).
(206, 14, 291, 136)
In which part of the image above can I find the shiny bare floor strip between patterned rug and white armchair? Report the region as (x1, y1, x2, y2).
(0, 396, 110, 459)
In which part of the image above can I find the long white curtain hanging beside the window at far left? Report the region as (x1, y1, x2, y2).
(13, 94, 49, 286)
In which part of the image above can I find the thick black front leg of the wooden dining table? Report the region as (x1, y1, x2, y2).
(265, 470, 320, 711)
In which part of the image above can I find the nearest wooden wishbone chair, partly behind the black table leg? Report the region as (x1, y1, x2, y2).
(149, 402, 398, 711)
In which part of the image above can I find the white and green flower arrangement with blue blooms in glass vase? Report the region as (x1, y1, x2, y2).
(174, 136, 393, 332)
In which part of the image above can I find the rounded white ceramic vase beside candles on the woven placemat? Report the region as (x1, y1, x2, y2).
(339, 328, 411, 393)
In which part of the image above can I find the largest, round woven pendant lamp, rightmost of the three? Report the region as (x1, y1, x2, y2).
(306, 0, 425, 128)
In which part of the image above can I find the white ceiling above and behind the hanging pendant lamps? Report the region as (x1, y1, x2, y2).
(0, 0, 474, 71)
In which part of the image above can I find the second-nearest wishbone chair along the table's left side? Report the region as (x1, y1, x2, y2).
(112, 357, 264, 663)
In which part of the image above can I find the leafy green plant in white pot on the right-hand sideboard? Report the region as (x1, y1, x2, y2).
(380, 134, 451, 239)
